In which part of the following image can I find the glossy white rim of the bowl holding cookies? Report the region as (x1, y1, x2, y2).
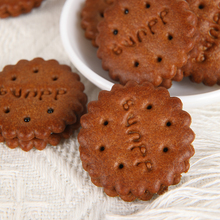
(60, 0, 220, 109)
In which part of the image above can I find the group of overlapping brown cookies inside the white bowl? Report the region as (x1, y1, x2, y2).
(82, 0, 220, 88)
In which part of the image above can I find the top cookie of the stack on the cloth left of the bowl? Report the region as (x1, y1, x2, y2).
(0, 58, 87, 151)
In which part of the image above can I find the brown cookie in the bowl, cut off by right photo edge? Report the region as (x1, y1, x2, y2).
(182, 0, 220, 86)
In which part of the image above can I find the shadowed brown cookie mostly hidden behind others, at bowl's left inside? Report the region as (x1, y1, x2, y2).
(81, 0, 115, 47)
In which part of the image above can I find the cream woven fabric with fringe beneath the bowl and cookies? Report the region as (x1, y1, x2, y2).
(0, 0, 220, 220)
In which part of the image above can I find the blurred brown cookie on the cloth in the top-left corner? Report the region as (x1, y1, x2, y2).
(0, 0, 43, 18)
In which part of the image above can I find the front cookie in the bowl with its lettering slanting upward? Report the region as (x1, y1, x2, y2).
(96, 0, 197, 86)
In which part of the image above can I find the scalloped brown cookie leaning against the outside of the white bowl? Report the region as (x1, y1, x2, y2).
(78, 81, 194, 201)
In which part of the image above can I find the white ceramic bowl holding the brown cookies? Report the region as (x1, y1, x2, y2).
(60, 0, 220, 109)
